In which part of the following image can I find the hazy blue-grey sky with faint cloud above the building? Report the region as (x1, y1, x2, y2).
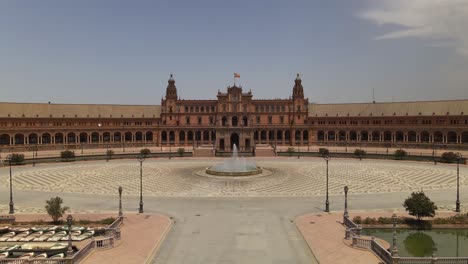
(0, 0, 468, 104)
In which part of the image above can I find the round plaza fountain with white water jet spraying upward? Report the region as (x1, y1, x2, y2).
(205, 144, 263, 176)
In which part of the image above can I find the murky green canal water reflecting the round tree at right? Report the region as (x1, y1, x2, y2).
(362, 229, 468, 257)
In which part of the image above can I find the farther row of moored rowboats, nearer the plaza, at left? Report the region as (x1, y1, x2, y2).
(0, 226, 95, 242)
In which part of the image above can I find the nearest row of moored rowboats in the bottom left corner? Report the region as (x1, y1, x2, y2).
(0, 243, 67, 260)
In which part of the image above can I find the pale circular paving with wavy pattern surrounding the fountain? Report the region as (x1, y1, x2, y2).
(0, 158, 468, 197)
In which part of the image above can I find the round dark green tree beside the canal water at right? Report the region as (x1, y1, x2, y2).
(403, 191, 437, 221)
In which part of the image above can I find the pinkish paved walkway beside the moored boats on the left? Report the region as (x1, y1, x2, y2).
(84, 214, 171, 264)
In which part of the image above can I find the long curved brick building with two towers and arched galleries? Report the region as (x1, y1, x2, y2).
(0, 75, 468, 152)
